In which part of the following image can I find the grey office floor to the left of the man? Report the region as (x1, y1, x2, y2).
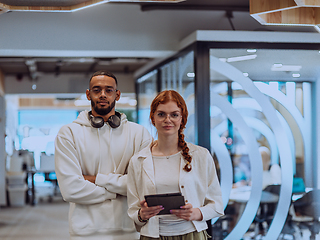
(0, 199, 69, 240)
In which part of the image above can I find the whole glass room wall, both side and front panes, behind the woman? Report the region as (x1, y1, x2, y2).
(137, 42, 320, 240)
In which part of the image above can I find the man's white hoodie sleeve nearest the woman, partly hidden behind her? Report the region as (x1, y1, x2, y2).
(95, 126, 152, 196)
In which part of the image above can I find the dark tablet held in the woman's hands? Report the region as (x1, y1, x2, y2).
(144, 192, 185, 215)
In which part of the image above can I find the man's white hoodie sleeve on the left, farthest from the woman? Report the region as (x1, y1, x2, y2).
(55, 126, 116, 204)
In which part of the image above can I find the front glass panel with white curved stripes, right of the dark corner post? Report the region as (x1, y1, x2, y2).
(210, 49, 312, 239)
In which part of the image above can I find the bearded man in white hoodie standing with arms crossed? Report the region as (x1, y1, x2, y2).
(55, 71, 152, 240)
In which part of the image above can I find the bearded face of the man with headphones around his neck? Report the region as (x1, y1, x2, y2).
(86, 75, 120, 117)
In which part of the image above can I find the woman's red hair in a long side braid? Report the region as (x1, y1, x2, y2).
(150, 90, 192, 172)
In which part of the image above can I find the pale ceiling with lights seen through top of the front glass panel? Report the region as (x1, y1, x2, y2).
(210, 49, 320, 82)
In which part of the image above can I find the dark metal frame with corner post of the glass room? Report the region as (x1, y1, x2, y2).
(136, 41, 320, 236)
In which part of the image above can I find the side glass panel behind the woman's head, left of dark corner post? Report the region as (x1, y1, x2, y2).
(136, 52, 195, 143)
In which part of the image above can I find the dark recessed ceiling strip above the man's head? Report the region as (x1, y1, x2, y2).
(0, 57, 152, 79)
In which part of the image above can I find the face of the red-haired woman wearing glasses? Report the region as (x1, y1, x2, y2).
(154, 101, 182, 136)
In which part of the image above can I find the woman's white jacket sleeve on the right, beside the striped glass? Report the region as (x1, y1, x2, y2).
(200, 151, 224, 221)
